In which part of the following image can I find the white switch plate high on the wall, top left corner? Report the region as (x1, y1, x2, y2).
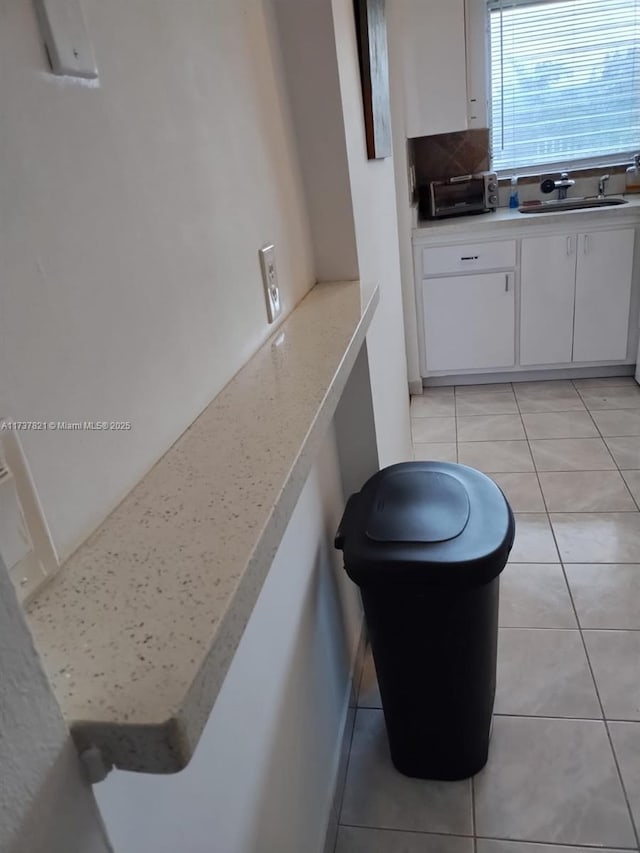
(36, 0, 98, 79)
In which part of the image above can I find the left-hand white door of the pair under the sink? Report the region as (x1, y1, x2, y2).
(520, 234, 578, 365)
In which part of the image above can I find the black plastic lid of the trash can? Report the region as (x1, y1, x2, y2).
(335, 462, 515, 586)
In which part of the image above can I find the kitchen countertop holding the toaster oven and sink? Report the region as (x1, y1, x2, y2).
(412, 194, 640, 239)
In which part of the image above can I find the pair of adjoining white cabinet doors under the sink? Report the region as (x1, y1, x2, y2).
(520, 228, 635, 366)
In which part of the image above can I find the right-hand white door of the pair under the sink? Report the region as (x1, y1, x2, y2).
(573, 228, 635, 361)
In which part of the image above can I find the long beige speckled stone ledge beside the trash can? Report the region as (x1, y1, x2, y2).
(27, 281, 378, 773)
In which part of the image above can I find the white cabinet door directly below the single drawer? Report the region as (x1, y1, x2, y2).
(422, 272, 515, 371)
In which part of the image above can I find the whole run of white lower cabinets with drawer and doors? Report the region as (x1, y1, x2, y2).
(414, 220, 636, 376)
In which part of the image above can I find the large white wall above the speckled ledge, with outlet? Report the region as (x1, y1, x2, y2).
(0, 0, 315, 556)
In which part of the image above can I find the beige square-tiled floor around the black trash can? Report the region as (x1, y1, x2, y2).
(335, 377, 640, 853)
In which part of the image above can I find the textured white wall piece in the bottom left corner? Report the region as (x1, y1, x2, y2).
(0, 560, 111, 853)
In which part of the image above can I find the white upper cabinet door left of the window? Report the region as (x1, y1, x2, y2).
(396, 0, 467, 137)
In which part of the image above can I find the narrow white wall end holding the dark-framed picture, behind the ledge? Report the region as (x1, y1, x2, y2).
(332, 0, 413, 466)
